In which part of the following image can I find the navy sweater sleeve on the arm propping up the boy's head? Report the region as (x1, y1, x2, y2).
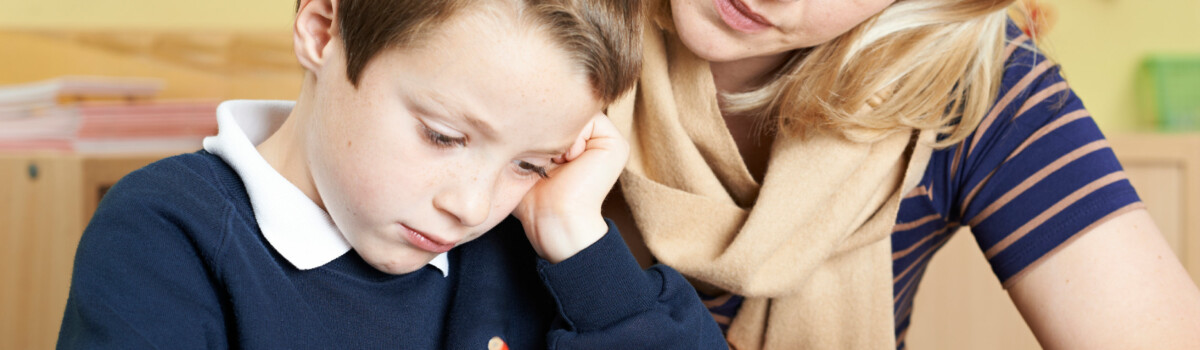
(539, 221, 728, 349)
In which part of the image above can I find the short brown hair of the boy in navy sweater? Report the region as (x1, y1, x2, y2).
(296, 0, 642, 104)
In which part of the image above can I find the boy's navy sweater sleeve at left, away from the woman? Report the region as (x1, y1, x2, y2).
(58, 165, 228, 349)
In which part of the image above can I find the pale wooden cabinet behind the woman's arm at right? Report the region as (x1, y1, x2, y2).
(907, 134, 1200, 350)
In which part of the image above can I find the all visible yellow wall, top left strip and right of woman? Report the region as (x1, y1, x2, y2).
(0, 0, 1200, 132)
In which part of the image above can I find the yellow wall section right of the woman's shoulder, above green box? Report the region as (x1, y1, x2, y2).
(1042, 0, 1200, 133)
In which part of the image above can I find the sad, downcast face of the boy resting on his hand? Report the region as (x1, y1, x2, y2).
(306, 11, 602, 273)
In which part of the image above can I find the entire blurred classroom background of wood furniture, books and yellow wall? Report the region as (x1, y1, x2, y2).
(0, 0, 1200, 349)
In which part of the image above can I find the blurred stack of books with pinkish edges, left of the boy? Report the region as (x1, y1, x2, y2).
(0, 77, 217, 152)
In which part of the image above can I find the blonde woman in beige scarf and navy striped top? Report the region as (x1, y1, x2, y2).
(606, 0, 1200, 349)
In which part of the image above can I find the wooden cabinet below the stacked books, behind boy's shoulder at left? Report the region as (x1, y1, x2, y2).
(0, 153, 166, 349)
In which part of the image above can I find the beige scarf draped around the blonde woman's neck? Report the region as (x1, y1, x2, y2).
(608, 30, 934, 349)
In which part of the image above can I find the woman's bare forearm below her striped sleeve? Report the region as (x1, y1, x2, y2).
(1008, 210, 1200, 349)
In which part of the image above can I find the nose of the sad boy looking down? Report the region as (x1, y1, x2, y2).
(433, 175, 492, 227)
